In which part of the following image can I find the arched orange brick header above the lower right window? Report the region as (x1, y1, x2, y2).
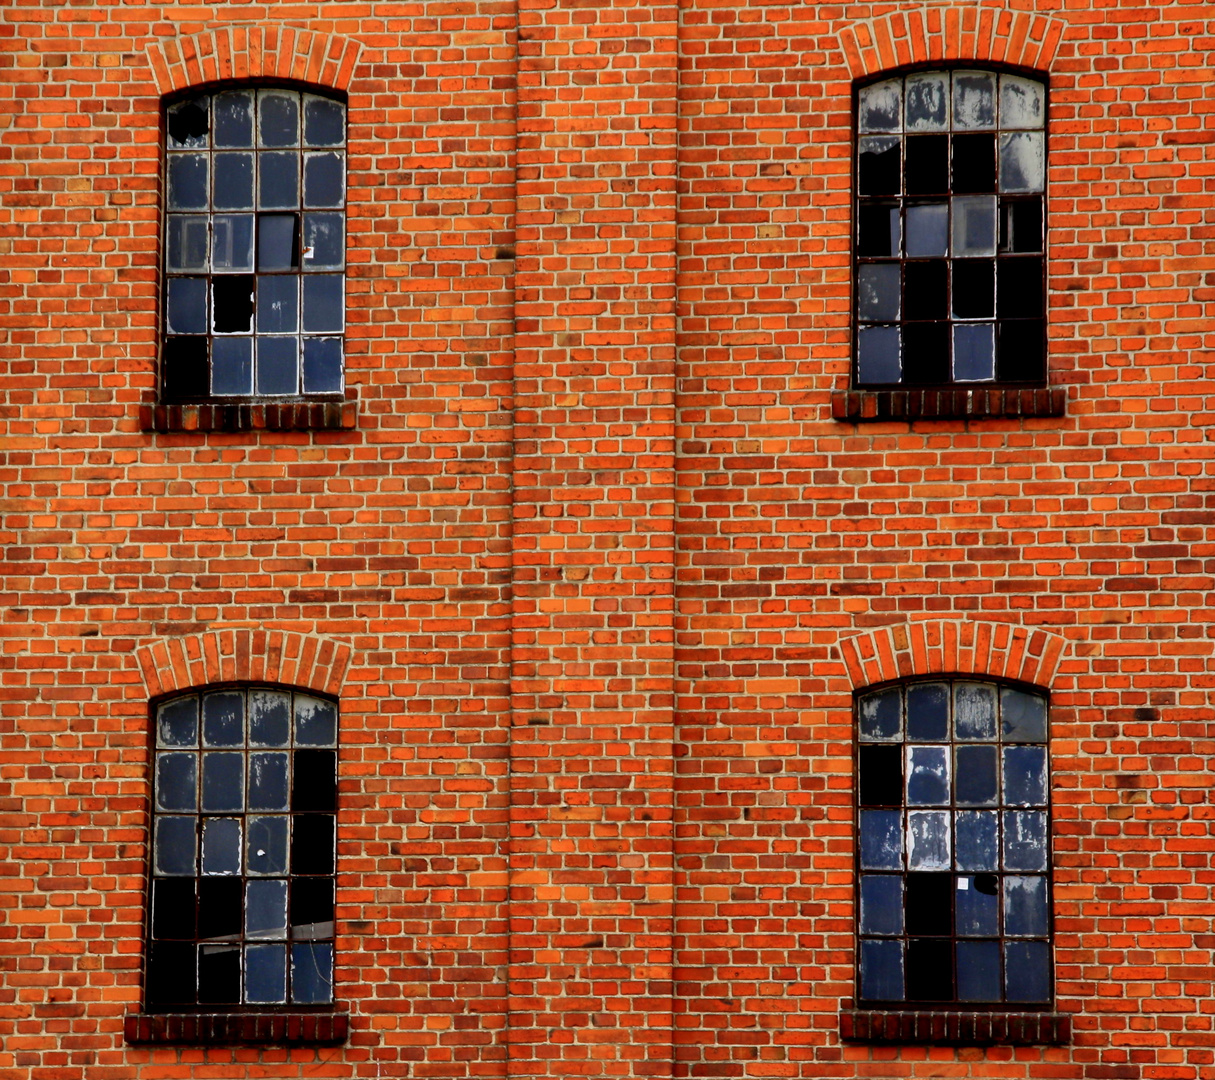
(840, 620, 1067, 689)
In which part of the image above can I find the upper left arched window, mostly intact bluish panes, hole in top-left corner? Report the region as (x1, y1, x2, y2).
(163, 90, 346, 401)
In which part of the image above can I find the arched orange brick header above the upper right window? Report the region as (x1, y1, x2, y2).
(840, 5, 1067, 79)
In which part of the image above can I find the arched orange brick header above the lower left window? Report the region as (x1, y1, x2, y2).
(135, 629, 351, 697)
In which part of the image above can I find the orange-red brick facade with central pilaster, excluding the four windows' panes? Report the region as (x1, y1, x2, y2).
(0, 0, 1215, 1080)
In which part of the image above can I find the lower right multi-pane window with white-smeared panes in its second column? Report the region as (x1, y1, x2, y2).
(858, 680, 1051, 1006)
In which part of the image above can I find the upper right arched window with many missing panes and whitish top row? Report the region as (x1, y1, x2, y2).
(855, 72, 1046, 385)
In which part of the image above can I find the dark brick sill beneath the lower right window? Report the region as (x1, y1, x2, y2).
(840, 1010, 1072, 1046)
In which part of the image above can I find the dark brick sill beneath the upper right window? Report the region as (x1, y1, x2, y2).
(831, 386, 1067, 424)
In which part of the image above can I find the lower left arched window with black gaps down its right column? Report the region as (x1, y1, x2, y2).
(147, 688, 338, 1010)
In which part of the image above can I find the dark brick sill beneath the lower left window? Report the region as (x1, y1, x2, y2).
(123, 1012, 350, 1046)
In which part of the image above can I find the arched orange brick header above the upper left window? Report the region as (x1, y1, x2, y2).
(148, 24, 362, 95)
